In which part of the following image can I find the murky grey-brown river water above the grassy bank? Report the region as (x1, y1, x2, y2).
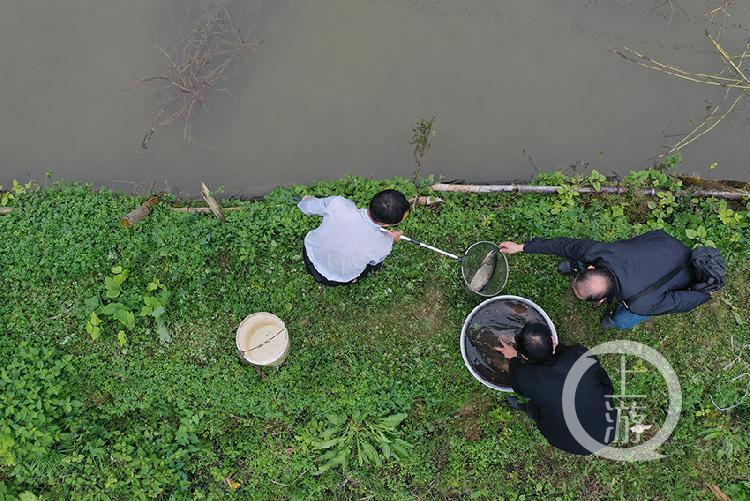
(0, 0, 750, 193)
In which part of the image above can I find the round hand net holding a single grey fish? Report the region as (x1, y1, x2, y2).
(461, 241, 509, 297)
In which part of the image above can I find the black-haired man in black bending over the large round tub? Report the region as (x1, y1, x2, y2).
(495, 323, 617, 455)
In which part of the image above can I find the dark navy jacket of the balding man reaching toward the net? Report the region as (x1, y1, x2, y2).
(524, 230, 711, 315)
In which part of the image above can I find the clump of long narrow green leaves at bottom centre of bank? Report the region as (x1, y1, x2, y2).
(314, 414, 413, 474)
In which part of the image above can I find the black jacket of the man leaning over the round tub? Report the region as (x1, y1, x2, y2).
(510, 344, 617, 455)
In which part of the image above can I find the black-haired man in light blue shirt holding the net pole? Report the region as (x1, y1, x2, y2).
(297, 190, 410, 286)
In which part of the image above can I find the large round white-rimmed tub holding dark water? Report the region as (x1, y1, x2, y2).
(462, 296, 556, 389)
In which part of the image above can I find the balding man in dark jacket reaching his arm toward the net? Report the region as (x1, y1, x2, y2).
(500, 230, 711, 329)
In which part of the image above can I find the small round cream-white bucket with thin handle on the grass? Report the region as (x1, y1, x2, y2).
(235, 312, 289, 367)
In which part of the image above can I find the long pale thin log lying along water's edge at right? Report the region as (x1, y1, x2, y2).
(431, 183, 750, 200)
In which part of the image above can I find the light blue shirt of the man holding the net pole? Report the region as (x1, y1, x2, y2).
(297, 197, 393, 282)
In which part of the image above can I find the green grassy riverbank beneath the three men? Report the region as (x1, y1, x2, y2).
(0, 172, 750, 499)
